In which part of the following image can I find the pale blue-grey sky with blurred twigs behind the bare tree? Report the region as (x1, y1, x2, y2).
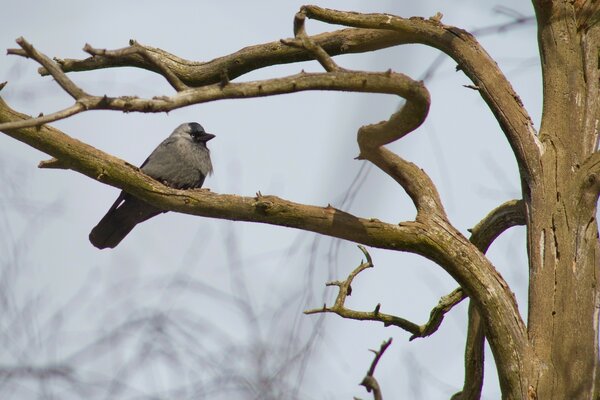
(0, 0, 541, 399)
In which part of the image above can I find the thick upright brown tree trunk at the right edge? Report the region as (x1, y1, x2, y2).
(525, 1, 600, 399)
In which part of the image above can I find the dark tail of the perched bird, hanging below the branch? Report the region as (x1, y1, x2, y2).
(89, 193, 163, 249)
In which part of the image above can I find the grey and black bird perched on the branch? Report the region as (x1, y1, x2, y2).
(89, 122, 215, 249)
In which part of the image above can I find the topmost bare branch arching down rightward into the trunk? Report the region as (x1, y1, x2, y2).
(302, 6, 540, 183)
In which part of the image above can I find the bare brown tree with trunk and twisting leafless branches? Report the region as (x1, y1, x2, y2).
(0, 1, 600, 399)
